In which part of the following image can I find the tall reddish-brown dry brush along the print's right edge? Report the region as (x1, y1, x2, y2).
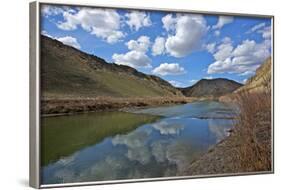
(234, 90, 271, 172)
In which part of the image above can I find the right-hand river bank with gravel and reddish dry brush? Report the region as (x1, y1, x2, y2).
(179, 93, 272, 176)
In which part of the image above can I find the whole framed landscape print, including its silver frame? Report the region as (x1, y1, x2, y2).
(30, 1, 274, 188)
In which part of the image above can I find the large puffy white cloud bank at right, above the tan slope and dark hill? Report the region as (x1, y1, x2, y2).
(207, 37, 270, 75)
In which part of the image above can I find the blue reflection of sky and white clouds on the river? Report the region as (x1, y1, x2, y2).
(42, 101, 233, 184)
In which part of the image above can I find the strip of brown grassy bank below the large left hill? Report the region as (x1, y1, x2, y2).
(41, 96, 214, 116)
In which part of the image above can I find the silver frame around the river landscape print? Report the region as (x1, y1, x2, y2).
(29, 0, 275, 188)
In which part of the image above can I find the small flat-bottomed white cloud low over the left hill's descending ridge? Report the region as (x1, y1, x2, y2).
(152, 63, 185, 76)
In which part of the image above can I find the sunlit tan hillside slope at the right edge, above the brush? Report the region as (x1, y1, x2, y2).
(235, 57, 271, 93)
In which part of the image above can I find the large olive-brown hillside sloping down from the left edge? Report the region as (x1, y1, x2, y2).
(41, 35, 183, 98)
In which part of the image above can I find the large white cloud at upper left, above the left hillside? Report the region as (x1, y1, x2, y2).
(57, 8, 125, 44)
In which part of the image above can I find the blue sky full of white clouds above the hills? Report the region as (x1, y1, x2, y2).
(41, 5, 271, 87)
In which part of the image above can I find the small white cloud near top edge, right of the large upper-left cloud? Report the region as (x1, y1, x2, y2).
(125, 11, 152, 31)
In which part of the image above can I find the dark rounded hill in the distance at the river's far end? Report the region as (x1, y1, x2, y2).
(180, 78, 242, 97)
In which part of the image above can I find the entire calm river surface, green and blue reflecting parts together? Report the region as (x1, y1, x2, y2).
(41, 101, 234, 184)
